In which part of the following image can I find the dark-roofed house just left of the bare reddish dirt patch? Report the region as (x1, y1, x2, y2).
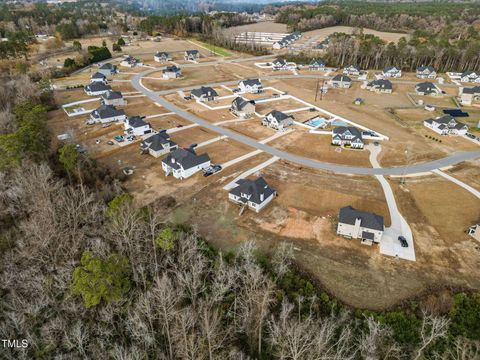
(228, 177, 277, 213)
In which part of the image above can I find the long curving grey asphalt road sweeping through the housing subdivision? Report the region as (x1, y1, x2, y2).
(132, 70, 480, 175)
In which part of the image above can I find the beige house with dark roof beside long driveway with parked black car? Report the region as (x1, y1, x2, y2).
(337, 206, 385, 245)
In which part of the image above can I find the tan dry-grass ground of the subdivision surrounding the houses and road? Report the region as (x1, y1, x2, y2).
(49, 44, 480, 309)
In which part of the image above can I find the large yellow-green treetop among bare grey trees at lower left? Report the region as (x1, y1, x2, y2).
(72, 251, 131, 308)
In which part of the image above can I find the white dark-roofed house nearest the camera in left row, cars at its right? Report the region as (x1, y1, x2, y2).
(162, 147, 211, 179)
